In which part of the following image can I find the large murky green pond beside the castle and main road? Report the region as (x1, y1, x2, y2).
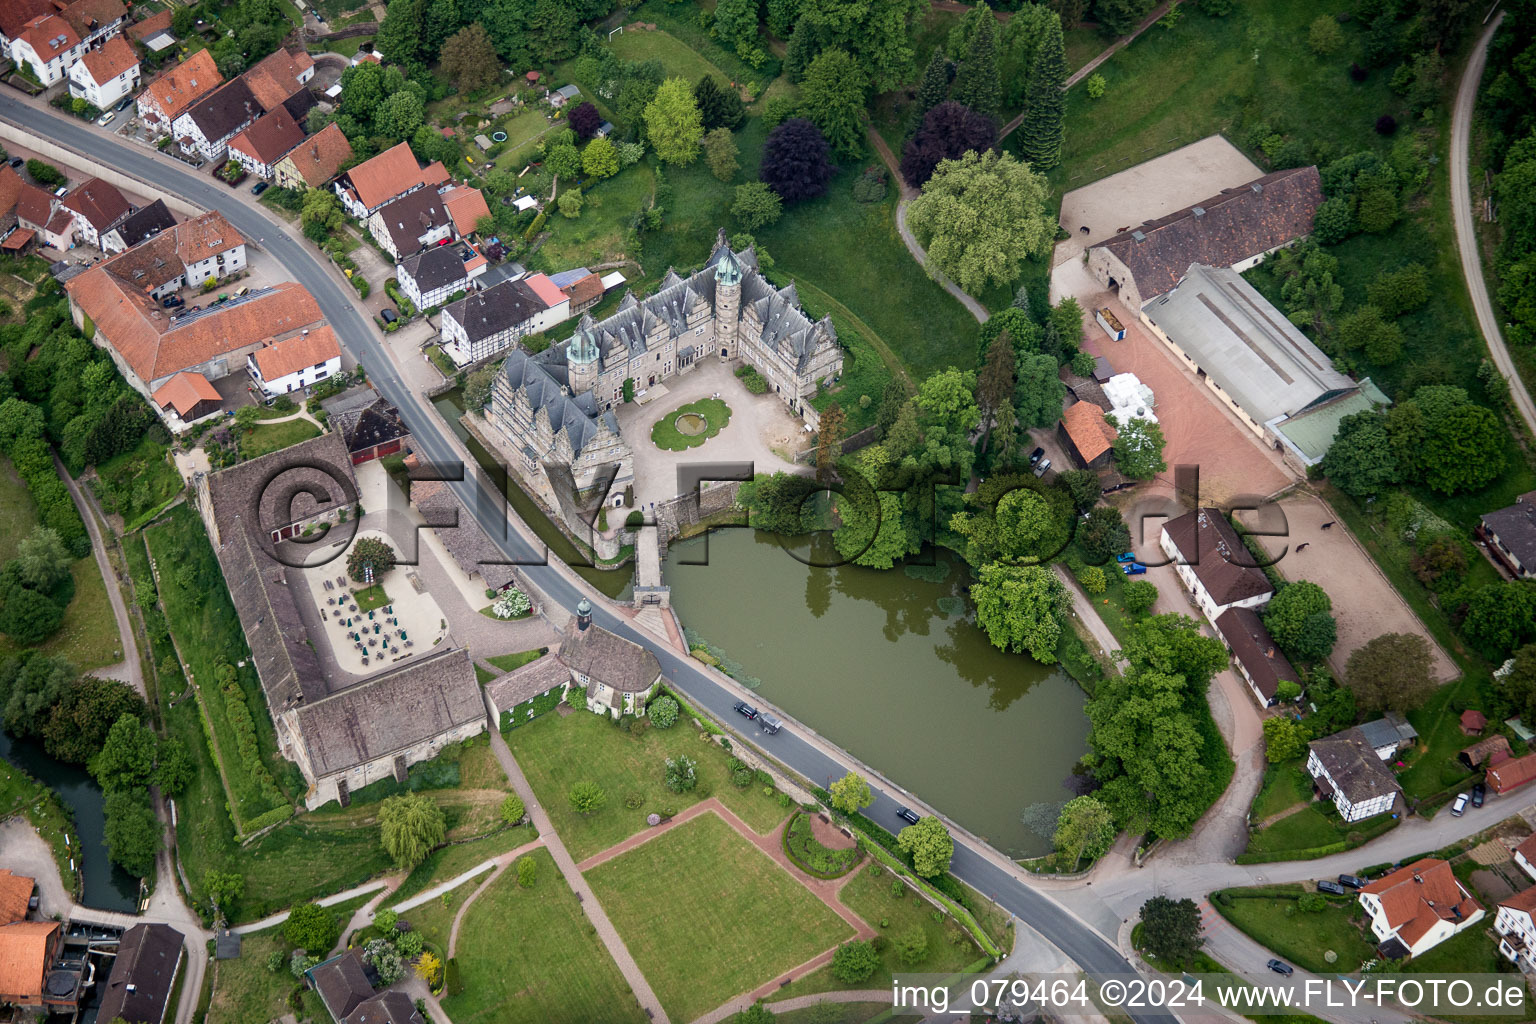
(665, 530, 1087, 857)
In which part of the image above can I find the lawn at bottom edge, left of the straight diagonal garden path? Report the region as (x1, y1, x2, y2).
(442, 849, 645, 1024)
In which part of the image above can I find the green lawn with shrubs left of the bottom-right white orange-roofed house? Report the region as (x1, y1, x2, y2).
(1210, 886, 1376, 975)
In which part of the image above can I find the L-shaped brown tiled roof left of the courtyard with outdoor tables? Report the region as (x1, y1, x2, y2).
(207, 433, 358, 715)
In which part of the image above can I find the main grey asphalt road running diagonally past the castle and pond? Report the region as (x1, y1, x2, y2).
(0, 94, 1167, 1024)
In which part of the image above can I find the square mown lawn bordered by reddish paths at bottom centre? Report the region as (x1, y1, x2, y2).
(587, 814, 851, 1021)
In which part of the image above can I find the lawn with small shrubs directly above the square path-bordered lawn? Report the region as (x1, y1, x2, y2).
(507, 700, 790, 861)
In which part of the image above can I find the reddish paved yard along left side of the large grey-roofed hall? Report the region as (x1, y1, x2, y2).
(1051, 261, 1295, 504)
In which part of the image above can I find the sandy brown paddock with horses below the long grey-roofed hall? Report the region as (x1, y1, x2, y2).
(1236, 493, 1456, 682)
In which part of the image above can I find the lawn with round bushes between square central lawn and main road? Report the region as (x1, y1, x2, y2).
(774, 863, 986, 999)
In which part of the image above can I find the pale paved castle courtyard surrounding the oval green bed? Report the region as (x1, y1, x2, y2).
(614, 358, 811, 508)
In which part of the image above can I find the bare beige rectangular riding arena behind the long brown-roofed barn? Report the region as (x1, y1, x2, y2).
(1052, 135, 1264, 264)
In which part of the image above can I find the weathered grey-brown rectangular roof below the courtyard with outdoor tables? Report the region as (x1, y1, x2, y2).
(295, 648, 485, 776)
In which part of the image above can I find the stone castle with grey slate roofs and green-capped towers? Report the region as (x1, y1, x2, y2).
(485, 229, 843, 504)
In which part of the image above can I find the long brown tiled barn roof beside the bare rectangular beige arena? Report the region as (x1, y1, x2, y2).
(1095, 166, 1322, 302)
